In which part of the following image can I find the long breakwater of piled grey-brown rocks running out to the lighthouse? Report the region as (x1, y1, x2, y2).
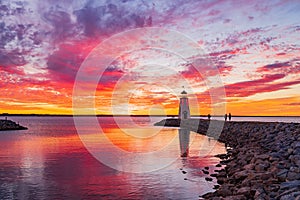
(155, 119, 300, 200)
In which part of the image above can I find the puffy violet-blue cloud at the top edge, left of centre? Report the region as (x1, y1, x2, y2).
(74, 1, 152, 37)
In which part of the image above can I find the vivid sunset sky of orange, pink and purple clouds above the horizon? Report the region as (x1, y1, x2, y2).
(0, 0, 300, 116)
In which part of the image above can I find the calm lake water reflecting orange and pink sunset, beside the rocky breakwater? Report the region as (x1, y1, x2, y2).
(0, 117, 225, 200)
